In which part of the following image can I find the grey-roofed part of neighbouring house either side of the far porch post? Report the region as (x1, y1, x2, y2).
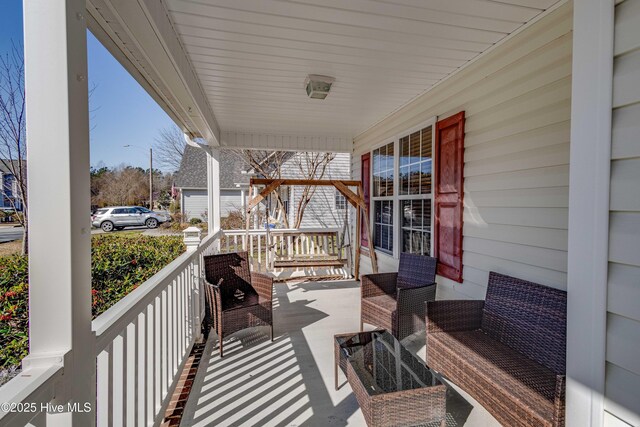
(175, 145, 249, 221)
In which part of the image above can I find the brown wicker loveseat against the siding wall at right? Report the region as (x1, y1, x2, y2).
(426, 272, 567, 426)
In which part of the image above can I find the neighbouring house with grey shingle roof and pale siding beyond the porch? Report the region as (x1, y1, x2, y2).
(175, 146, 350, 228)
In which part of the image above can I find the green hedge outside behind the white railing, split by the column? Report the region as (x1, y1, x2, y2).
(0, 234, 185, 368)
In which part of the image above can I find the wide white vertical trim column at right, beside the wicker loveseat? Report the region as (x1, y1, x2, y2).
(566, 0, 614, 427)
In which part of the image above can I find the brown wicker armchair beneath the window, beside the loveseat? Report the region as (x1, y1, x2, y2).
(360, 253, 437, 340)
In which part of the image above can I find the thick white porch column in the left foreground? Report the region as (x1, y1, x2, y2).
(24, 0, 96, 426)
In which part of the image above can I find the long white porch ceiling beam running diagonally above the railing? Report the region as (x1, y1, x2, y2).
(87, 0, 220, 146)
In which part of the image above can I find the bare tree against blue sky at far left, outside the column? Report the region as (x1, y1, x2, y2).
(0, 44, 29, 254)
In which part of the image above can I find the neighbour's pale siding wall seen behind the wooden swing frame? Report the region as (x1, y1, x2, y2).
(282, 153, 351, 228)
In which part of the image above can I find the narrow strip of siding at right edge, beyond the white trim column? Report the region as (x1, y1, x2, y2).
(605, 0, 640, 427)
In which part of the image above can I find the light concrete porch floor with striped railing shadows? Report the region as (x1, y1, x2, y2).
(181, 280, 500, 427)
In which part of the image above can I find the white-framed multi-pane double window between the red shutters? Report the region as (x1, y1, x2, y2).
(371, 118, 436, 257)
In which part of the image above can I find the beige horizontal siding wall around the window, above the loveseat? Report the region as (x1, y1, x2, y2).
(351, 3, 572, 299)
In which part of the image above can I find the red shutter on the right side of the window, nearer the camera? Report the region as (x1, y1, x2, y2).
(434, 111, 464, 283)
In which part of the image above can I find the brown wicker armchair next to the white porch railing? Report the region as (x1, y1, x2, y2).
(204, 252, 273, 357)
